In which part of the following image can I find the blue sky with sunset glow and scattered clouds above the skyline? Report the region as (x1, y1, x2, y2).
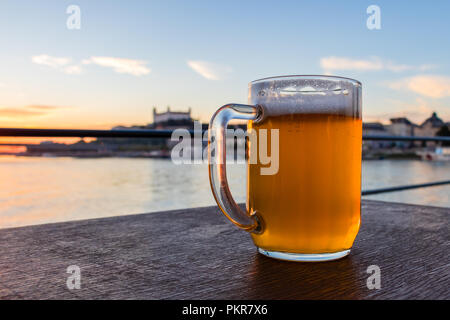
(0, 0, 450, 128)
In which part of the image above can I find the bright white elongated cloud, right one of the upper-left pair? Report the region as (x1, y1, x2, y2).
(82, 57, 151, 76)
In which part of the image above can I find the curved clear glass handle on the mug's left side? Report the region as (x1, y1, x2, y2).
(208, 104, 262, 233)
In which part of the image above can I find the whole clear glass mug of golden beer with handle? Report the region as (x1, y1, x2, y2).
(208, 76, 362, 261)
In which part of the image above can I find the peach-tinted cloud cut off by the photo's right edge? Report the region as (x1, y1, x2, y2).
(387, 75, 450, 98)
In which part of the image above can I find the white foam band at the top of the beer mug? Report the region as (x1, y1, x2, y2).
(249, 78, 361, 117)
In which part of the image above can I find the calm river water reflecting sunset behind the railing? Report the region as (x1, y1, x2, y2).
(0, 156, 450, 228)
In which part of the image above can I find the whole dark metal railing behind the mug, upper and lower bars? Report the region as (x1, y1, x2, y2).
(0, 128, 450, 196)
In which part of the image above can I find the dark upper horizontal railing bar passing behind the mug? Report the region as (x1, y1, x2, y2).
(0, 128, 450, 142)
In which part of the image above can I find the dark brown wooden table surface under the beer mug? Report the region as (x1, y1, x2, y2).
(0, 200, 450, 299)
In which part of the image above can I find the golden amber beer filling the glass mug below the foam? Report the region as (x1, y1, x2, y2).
(247, 114, 362, 254)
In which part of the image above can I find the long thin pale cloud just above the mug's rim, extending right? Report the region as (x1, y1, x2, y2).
(320, 56, 434, 73)
